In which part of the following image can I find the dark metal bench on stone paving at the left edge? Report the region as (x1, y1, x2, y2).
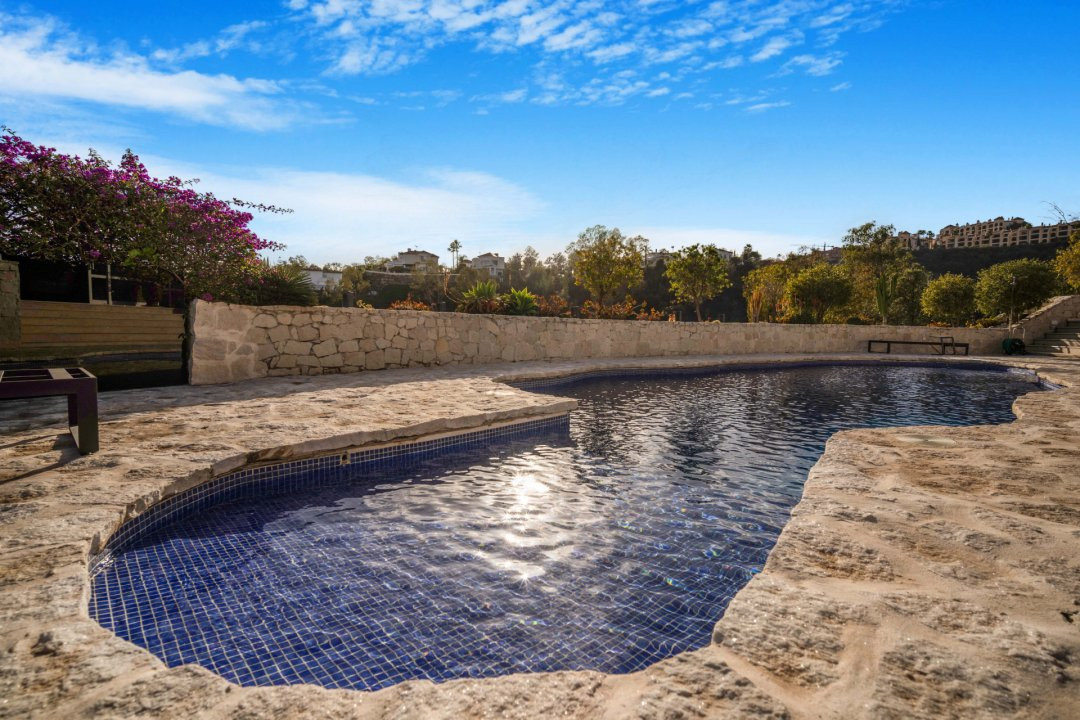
(0, 367, 98, 454)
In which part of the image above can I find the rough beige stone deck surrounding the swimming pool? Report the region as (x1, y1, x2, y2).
(0, 354, 1080, 720)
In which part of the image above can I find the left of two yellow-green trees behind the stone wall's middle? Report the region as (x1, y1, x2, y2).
(567, 225, 646, 308)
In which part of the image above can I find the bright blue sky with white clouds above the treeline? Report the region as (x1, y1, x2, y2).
(0, 0, 1080, 262)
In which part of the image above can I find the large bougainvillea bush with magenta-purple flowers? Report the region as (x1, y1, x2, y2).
(0, 128, 289, 300)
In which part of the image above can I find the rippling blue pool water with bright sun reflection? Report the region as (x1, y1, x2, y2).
(91, 366, 1036, 690)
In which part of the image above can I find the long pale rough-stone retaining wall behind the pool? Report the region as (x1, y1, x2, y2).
(190, 300, 1005, 385)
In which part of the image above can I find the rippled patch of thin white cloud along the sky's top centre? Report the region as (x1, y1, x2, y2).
(287, 0, 896, 105)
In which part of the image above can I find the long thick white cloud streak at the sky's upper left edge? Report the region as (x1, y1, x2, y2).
(0, 16, 295, 131)
